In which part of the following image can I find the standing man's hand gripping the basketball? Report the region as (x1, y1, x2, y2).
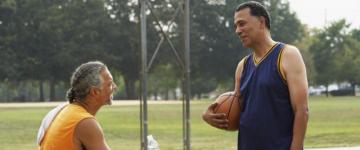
(202, 103, 229, 129)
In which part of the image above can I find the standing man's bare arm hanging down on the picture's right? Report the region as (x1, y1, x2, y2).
(281, 45, 309, 150)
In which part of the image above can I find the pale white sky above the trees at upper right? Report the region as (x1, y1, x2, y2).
(288, 0, 360, 28)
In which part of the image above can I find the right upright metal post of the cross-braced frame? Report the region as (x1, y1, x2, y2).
(184, 0, 190, 150)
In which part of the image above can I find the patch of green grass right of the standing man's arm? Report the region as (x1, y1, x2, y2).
(305, 97, 360, 147)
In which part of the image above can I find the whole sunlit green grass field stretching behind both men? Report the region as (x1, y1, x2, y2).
(0, 97, 360, 150)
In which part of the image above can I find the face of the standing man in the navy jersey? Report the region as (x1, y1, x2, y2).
(234, 8, 262, 48)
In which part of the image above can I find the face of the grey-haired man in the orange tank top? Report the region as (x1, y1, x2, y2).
(99, 69, 117, 105)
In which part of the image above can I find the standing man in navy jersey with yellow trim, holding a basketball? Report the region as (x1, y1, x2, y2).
(202, 1, 308, 150)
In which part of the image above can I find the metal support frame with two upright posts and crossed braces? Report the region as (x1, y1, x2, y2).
(138, 0, 190, 150)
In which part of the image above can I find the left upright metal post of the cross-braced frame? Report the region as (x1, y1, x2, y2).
(140, 0, 148, 150)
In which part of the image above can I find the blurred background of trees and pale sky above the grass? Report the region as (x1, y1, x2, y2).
(0, 0, 360, 102)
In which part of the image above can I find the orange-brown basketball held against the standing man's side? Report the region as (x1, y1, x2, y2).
(214, 92, 241, 131)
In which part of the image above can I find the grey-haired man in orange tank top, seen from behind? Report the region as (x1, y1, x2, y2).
(40, 61, 117, 150)
